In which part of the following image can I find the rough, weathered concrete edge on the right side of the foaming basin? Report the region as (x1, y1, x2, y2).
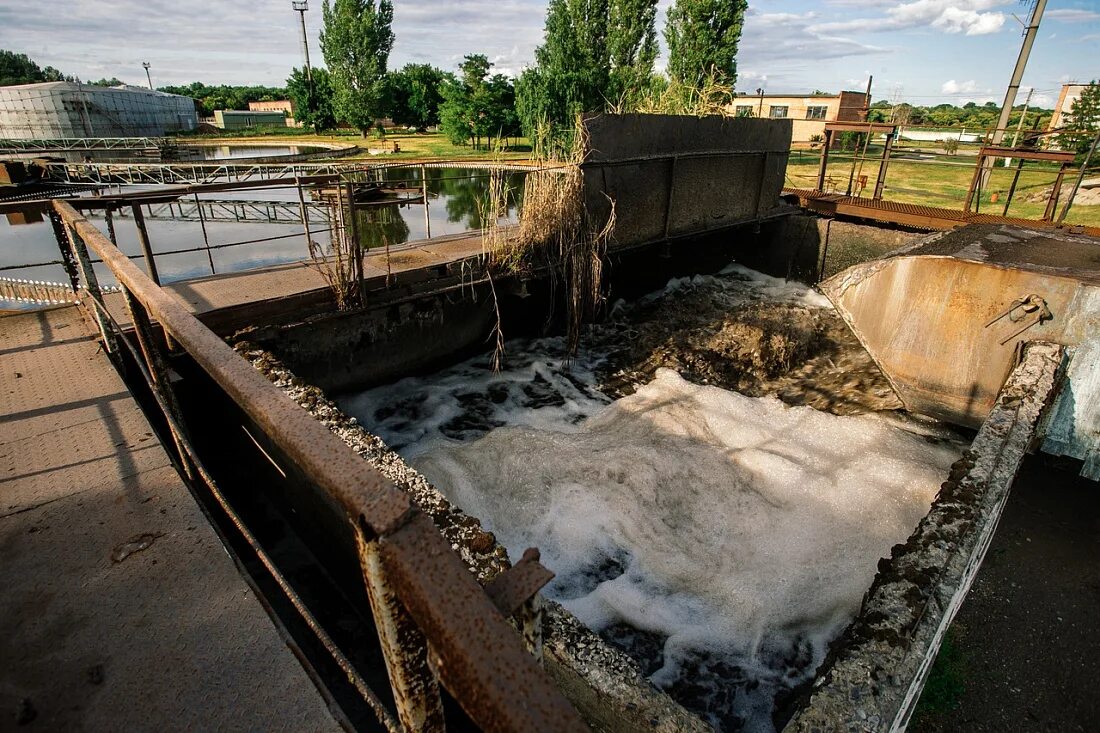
(783, 342, 1066, 733)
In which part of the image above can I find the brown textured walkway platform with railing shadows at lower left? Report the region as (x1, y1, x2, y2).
(0, 306, 340, 731)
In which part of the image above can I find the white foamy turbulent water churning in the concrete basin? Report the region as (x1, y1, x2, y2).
(341, 269, 958, 731)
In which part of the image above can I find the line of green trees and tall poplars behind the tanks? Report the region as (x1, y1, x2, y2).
(287, 0, 748, 145)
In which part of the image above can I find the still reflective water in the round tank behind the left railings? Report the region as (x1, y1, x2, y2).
(0, 167, 524, 299)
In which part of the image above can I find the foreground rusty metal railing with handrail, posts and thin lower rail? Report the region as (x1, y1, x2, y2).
(52, 195, 586, 732)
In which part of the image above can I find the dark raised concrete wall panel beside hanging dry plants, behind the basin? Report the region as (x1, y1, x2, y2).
(583, 114, 791, 247)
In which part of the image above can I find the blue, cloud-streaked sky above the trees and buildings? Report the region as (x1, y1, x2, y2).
(0, 0, 1100, 108)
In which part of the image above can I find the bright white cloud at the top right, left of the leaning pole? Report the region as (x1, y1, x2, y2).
(811, 0, 1004, 35)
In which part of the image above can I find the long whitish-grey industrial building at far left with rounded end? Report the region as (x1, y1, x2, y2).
(0, 81, 198, 140)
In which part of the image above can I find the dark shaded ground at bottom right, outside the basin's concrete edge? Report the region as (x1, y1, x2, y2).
(909, 458, 1100, 733)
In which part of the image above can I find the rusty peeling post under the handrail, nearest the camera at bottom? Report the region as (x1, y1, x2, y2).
(355, 526, 444, 733)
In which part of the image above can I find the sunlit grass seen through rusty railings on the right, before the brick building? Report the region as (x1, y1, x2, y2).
(787, 141, 1100, 227)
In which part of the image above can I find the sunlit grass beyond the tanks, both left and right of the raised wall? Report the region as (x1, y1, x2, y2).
(184, 128, 1100, 227)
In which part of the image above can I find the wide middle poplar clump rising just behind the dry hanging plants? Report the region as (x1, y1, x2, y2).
(516, 0, 657, 145)
